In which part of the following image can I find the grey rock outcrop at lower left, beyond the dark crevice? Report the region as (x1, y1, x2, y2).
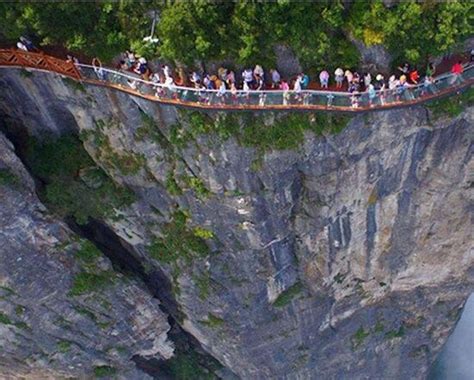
(0, 128, 173, 379)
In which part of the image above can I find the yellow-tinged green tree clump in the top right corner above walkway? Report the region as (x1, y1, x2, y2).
(346, 1, 474, 63)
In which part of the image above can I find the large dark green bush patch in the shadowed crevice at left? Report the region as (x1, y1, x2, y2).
(26, 134, 134, 224)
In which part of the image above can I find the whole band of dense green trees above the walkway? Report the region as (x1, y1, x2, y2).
(0, 0, 474, 70)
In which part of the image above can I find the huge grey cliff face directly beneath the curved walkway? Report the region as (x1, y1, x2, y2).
(0, 70, 474, 379)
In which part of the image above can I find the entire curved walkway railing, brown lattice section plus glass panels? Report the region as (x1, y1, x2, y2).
(0, 49, 474, 113)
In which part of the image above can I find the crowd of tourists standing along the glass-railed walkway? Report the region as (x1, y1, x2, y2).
(101, 51, 470, 107)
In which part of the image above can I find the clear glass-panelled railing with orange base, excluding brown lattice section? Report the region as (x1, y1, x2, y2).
(77, 64, 474, 111)
